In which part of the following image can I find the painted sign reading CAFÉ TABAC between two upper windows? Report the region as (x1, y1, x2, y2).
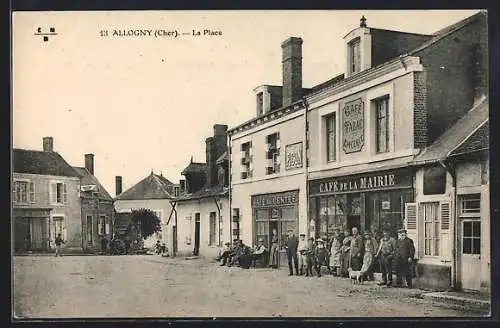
(342, 98, 365, 154)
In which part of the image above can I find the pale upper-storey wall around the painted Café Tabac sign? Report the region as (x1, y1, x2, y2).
(308, 73, 413, 172)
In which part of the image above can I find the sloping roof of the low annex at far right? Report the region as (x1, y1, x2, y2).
(414, 98, 489, 164)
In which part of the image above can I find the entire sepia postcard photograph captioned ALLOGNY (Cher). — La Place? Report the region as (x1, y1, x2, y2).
(10, 9, 492, 321)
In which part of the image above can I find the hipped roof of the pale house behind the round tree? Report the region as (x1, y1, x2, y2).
(115, 172, 174, 200)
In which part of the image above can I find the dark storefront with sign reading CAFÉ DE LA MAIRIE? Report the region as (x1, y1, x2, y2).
(309, 168, 415, 240)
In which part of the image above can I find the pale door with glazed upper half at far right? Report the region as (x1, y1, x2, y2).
(460, 219, 481, 290)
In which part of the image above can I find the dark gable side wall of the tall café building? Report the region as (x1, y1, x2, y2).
(415, 16, 488, 144)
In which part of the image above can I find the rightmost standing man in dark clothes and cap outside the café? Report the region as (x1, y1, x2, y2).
(394, 229, 415, 288)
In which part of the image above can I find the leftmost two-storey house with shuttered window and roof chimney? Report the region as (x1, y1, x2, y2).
(12, 137, 82, 251)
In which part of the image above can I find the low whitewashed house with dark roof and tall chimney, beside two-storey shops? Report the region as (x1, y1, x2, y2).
(174, 124, 230, 257)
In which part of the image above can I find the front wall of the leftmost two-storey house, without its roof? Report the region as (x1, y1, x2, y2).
(14, 173, 82, 250)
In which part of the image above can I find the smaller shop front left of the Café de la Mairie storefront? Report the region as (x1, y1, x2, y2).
(252, 190, 299, 264)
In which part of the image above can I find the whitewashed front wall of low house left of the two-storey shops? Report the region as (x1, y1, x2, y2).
(172, 197, 230, 258)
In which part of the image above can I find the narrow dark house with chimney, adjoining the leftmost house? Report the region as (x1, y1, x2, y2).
(74, 154, 114, 251)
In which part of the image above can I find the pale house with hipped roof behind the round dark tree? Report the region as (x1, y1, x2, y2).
(114, 171, 179, 249)
